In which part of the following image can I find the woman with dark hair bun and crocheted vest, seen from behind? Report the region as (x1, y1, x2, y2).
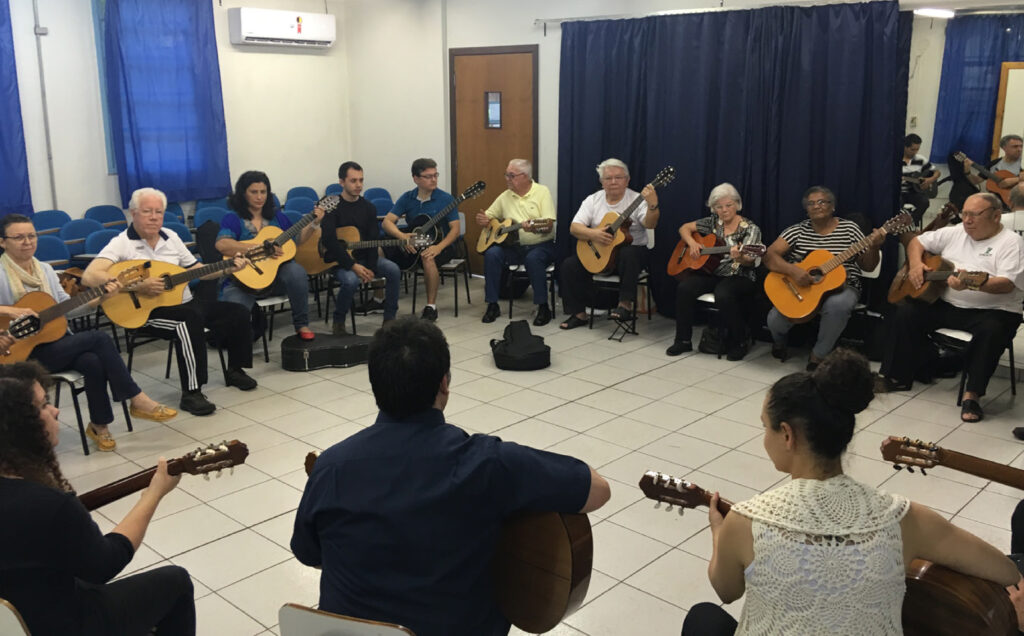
(683, 349, 1021, 635)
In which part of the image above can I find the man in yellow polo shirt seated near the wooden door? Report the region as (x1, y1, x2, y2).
(476, 159, 555, 327)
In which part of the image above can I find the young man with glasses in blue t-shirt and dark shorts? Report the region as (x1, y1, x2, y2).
(381, 159, 460, 321)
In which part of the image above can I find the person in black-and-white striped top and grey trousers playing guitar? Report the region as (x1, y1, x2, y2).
(765, 185, 885, 371)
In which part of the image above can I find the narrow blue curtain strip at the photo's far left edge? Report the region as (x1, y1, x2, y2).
(0, 0, 32, 217)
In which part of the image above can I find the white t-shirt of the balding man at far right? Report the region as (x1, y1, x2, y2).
(918, 225, 1024, 313)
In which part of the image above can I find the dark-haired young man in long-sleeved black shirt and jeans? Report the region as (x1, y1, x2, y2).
(321, 161, 401, 336)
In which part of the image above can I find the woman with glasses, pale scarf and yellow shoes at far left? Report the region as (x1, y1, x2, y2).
(0, 214, 178, 452)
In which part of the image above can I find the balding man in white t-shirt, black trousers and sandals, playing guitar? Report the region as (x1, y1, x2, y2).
(874, 193, 1024, 422)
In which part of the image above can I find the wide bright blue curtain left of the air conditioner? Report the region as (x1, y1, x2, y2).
(104, 0, 230, 206)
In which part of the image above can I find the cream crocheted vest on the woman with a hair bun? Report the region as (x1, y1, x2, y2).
(732, 475, 910, 636)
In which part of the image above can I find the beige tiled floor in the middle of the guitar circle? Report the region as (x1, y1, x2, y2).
(58, 280, 1024, 636)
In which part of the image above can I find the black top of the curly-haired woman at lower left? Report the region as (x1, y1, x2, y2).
(0, 477, 135, 634)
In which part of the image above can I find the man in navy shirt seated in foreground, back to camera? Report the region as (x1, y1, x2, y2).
(291, 317, 610, 636)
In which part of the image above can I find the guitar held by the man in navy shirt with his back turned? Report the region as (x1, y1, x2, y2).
(304, 453, 594, 634)
